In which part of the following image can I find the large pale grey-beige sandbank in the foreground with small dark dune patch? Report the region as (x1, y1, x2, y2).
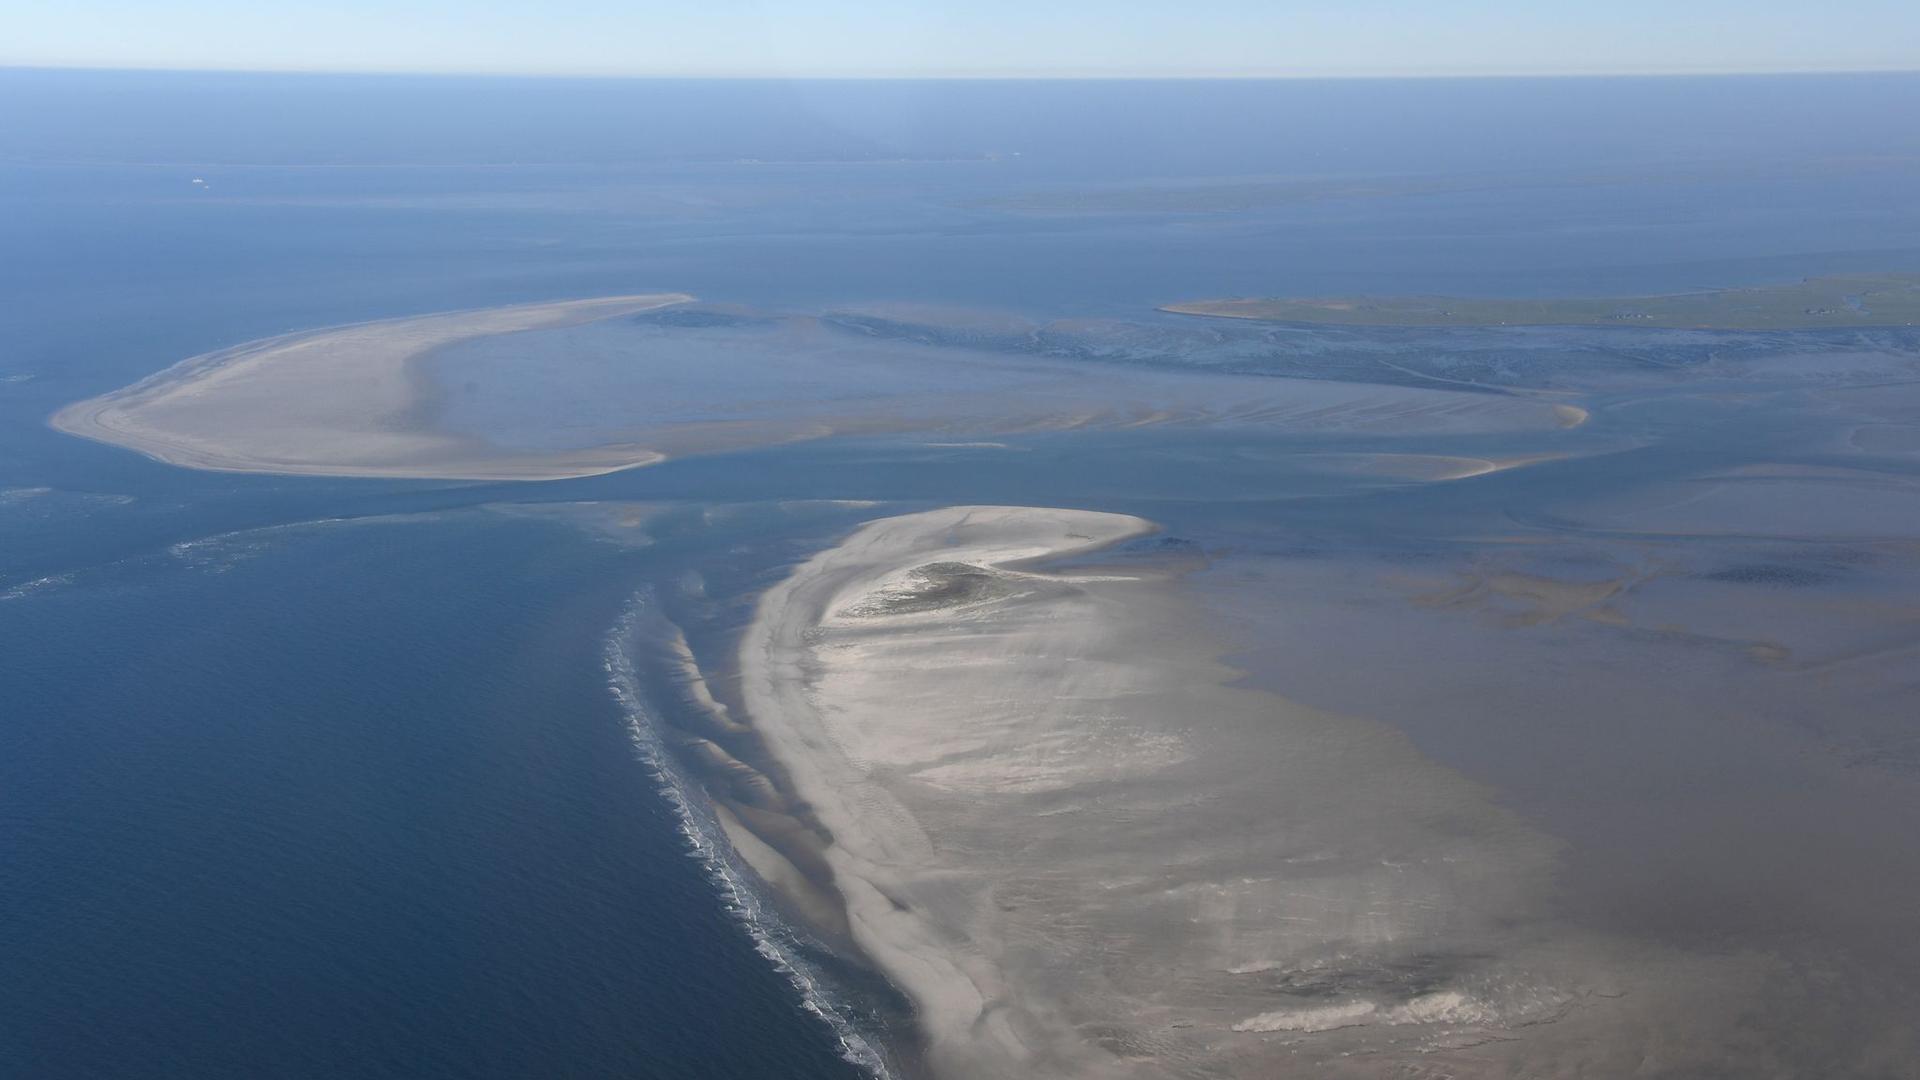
(739, 507, 1738, 1078)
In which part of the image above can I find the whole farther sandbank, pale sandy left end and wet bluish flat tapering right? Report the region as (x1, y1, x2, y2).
(50, 294, 1580, 480)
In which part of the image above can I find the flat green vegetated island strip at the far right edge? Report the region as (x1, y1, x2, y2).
(1162, 273, 1920, 331)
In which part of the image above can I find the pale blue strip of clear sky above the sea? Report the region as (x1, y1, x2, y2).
(0, 0, 1920, 77)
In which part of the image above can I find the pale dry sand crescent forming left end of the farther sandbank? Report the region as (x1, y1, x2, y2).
(48, 292, 691, 480)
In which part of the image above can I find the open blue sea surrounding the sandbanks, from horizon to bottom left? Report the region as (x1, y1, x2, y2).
(0, 71, 1920, 1078)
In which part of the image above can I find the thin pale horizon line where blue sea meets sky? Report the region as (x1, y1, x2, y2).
(11, 60, 1920, 83)
